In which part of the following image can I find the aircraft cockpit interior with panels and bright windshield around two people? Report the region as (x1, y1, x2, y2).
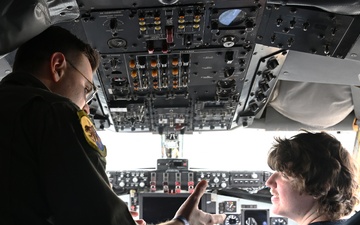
(0, 0, 360, 225)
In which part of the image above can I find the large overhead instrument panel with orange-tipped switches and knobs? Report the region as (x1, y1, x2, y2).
(71, 0, 358, 134)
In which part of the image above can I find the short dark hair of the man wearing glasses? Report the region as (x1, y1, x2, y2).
(13, 26, 99, 73)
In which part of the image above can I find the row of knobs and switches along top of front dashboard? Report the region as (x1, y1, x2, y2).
(108, 170, 271, 193)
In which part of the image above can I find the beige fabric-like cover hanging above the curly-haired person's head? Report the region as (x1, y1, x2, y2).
(269, 80, 354, 129)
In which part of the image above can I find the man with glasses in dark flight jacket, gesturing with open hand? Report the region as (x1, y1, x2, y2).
(0, 26, 225, 225)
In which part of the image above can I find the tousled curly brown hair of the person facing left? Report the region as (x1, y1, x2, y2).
(268, 131, 359, 220)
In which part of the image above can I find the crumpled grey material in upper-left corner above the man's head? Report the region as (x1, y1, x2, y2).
(0, 0, 80, 55)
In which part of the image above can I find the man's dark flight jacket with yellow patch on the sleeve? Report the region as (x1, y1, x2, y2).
(0, 73, 135, 225)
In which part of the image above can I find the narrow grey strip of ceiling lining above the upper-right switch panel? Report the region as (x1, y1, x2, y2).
(267, 0, 360, 16)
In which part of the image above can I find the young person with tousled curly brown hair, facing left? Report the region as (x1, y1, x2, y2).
(266, 130, 359, 225)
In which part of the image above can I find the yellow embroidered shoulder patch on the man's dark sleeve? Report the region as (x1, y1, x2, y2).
(77, 110, 107, 157)
